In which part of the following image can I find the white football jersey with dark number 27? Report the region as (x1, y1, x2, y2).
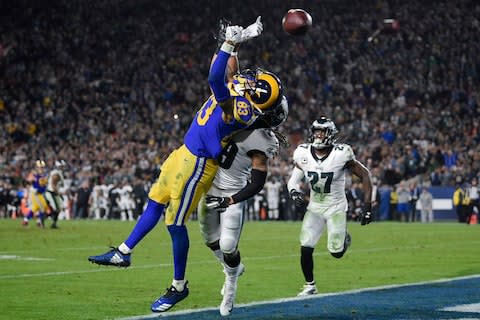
(293, 143, 355, 207)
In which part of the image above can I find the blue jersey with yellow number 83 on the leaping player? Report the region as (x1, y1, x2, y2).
(184, 96, 256, 159)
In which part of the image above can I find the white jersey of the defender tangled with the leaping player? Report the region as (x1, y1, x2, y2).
(213, 129, 280, 196)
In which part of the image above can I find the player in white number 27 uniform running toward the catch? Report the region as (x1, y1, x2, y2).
(287, 117, 372, 296)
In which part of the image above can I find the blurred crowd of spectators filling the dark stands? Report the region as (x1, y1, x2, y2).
(0, 0, 480, 220)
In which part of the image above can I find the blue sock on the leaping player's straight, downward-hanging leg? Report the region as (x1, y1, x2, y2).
(167, 225, 190, 280)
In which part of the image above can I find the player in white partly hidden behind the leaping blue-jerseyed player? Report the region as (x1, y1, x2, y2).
(198, 97, 288, 316)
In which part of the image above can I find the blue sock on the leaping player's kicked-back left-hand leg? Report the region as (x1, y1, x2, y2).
(125, 199, 165, 249)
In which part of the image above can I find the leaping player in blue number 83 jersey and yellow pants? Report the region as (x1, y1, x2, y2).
(88, 17, 282, 312)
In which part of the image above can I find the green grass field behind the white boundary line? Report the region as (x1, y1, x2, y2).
(0, 220, 480, 320)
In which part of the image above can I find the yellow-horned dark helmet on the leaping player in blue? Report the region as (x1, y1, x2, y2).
(233, 69, 283, 114)
